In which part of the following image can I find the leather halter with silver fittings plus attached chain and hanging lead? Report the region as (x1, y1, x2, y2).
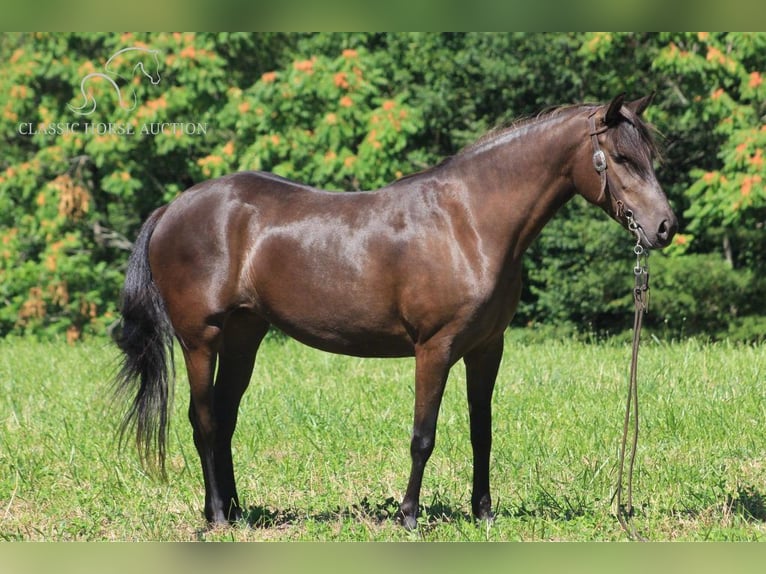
(588, 109, 649, 540)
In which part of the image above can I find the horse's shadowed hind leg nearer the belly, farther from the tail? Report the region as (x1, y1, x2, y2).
(214, 311, 269, 522)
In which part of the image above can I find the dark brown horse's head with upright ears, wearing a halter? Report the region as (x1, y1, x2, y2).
(575, 95, 678, 248)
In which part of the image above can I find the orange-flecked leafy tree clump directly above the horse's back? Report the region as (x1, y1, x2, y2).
(212, 49, 419, 190)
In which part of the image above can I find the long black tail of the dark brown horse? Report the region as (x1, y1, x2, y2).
(115, 207, 175, 474)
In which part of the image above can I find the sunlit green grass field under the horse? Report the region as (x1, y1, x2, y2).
(0, 332, 766, 541)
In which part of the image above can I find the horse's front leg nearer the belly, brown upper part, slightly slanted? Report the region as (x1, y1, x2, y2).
(399, 343, 450, 530)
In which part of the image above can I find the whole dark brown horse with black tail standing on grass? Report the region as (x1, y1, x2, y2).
(118, 96, 676, 528)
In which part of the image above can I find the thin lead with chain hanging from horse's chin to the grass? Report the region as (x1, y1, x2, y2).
(612, 210, 649, 540)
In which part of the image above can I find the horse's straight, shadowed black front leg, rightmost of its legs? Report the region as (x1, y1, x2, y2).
(463, 336, 503, 520)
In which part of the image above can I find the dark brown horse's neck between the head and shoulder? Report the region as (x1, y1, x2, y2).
(455, 114, 587, 261)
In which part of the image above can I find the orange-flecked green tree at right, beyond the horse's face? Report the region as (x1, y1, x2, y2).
(654, 33, 766, 240)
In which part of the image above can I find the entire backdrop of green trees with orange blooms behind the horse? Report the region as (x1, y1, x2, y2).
(0, 33, 766, 340)
